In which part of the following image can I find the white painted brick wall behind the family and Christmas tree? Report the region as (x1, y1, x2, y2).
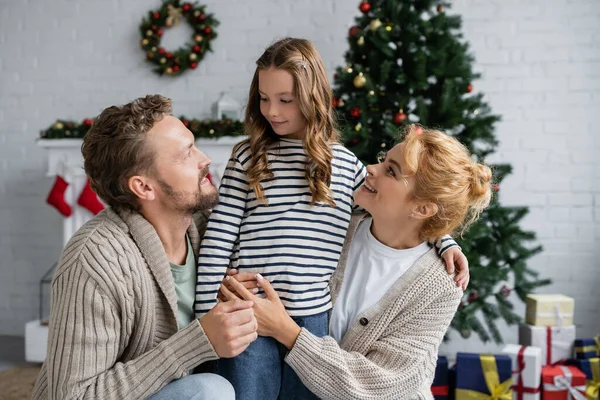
(0, 0, 600, 353)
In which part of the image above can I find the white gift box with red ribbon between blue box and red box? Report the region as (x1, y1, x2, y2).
(502, 344, 542, 400)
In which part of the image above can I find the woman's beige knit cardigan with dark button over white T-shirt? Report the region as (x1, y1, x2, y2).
(285, 214, 462, 400)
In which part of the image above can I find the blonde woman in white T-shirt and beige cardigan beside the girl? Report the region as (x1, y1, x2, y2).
(221, 125, 492, 400)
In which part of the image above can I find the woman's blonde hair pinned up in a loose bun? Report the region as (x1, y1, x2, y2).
(402, 124, 492, 239)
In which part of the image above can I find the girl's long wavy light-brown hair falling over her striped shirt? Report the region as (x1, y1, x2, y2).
(244, 38, 339, 205)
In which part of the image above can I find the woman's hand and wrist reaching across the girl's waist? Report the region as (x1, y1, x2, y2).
(221, 274, 301, 349)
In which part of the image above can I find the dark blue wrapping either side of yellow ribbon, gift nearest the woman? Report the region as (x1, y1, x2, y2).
(456, 353, 512, 400)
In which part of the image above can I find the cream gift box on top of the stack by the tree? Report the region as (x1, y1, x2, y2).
(525, 294, 575, 326)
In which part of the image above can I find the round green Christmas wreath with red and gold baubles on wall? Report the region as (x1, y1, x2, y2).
(140, 0, 219, 76)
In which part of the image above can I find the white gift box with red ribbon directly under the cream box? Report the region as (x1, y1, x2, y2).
(519, 325, 575, 365)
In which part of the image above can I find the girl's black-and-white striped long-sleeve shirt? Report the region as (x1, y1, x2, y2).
(195, 139, 366, 316)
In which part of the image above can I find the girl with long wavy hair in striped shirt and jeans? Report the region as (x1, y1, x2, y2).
(195, 38, 462, 400)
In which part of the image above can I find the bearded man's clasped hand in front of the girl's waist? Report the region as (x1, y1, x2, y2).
(200, 299, 258, 358)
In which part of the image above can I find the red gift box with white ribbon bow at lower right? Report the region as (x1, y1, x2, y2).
(542, 365, 587, 400)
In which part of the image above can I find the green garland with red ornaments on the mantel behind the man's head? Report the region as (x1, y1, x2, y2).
(40, 116, 244, 139)
